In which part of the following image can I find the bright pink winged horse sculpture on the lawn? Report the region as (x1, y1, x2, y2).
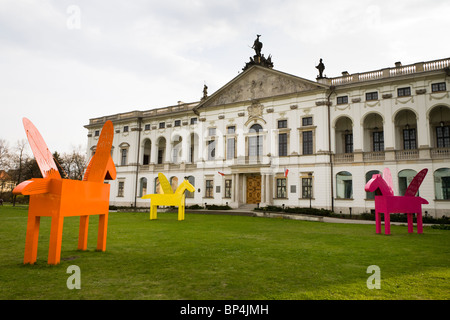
(365, 168, 428, 234)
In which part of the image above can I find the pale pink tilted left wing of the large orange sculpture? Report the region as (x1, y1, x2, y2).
(22, 118, 61, 179)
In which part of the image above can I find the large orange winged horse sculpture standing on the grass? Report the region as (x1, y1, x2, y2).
(13, 118, 116, 264)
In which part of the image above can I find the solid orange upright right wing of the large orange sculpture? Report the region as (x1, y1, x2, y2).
(83, 120, 115, 182)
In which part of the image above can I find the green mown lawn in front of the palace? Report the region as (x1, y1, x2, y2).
(0, 206, 450, 300)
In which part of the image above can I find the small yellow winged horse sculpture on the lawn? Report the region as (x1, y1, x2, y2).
(142, 173, 195, 220)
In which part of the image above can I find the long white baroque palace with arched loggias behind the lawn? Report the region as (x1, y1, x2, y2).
(85, 56, 450, 217)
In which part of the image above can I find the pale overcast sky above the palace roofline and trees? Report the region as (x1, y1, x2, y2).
(0, 0, 450, 153)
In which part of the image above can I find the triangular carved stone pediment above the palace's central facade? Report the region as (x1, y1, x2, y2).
(196, 66, 328, 109)
